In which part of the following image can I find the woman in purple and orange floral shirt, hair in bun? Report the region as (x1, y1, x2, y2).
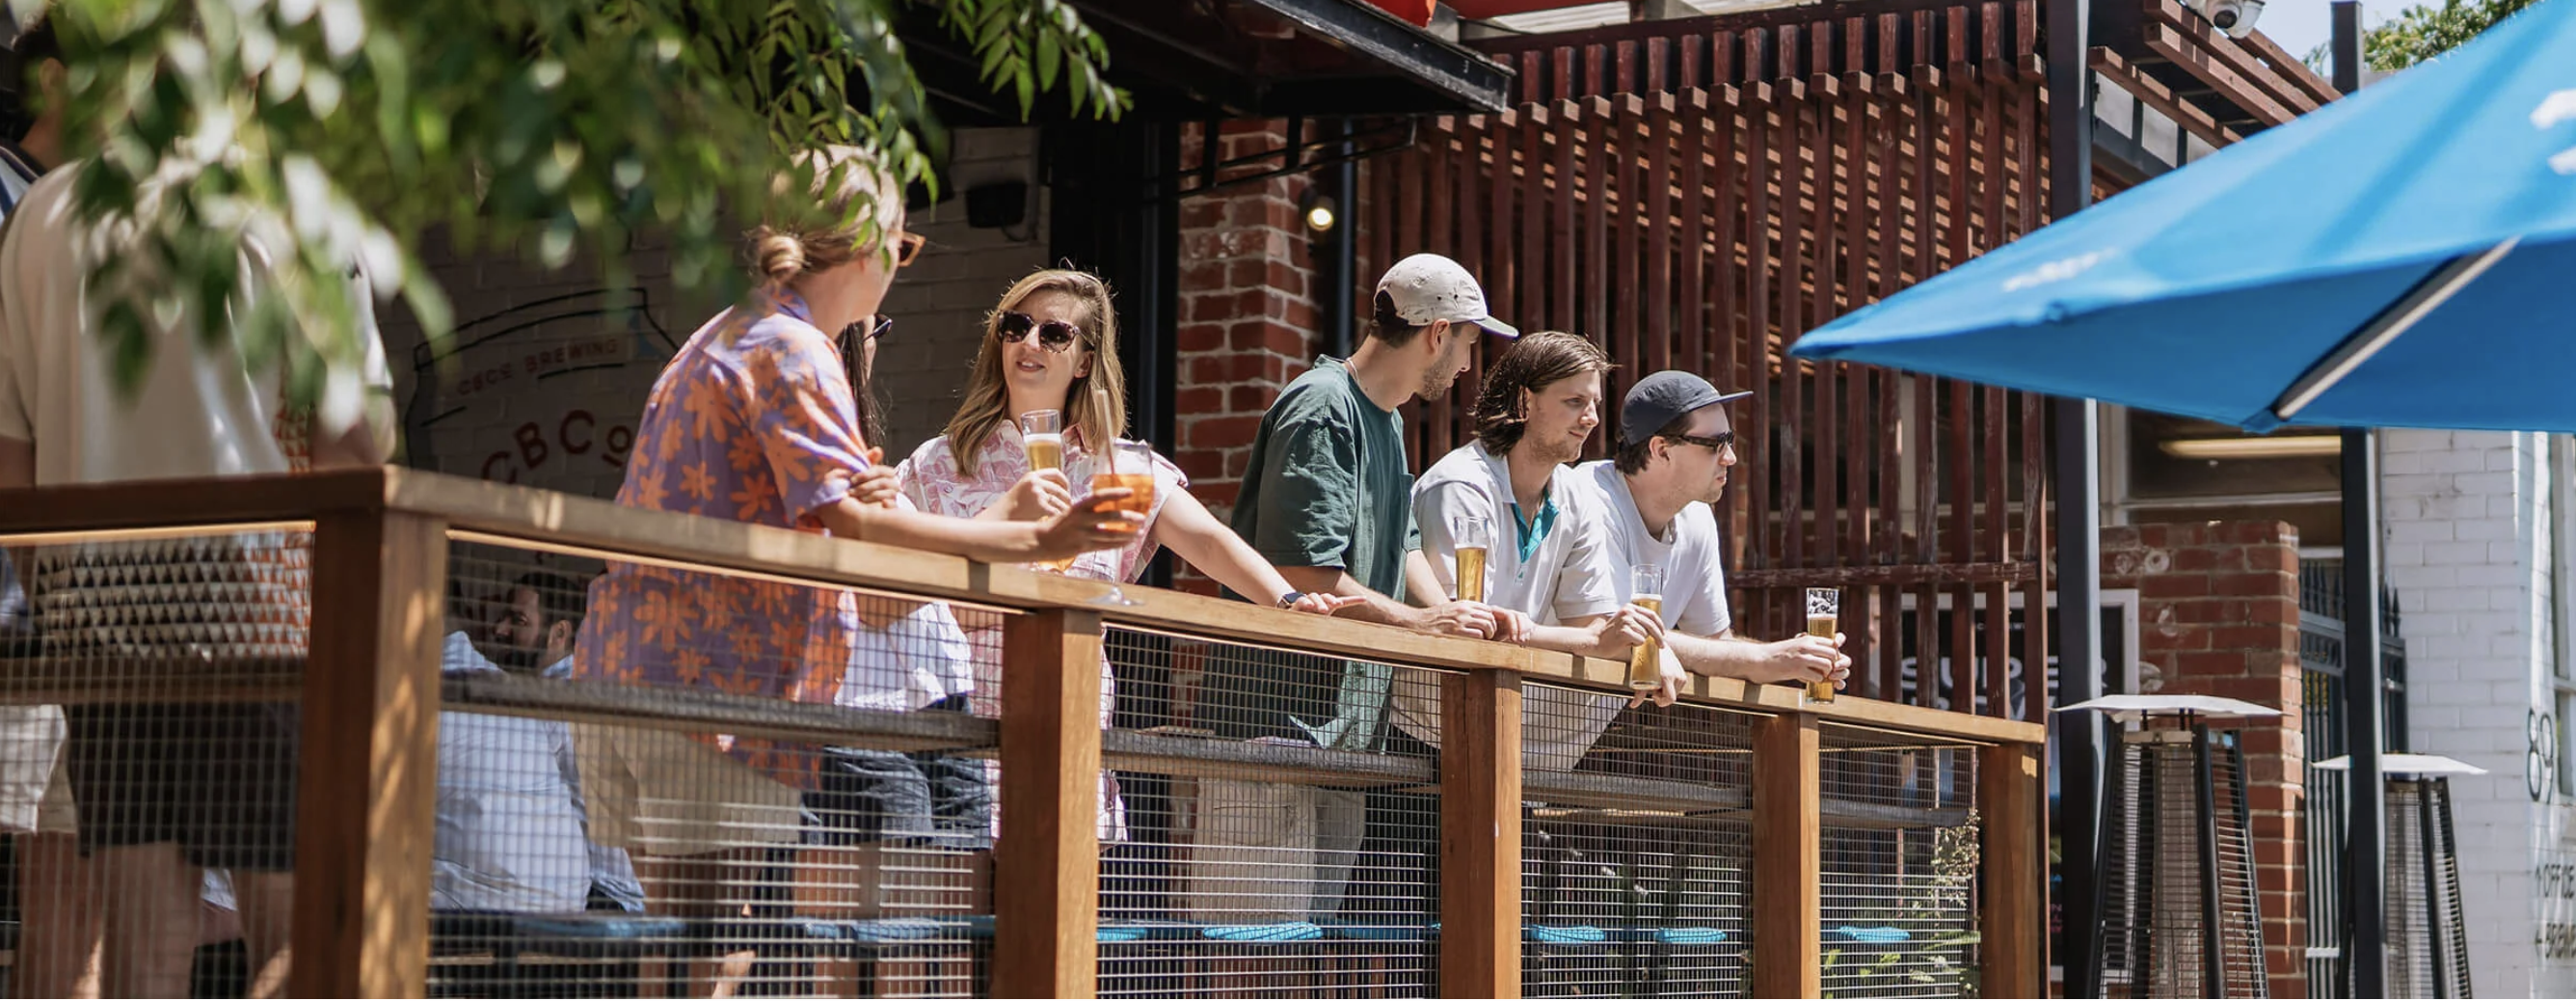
(575, 147, 1139, 944)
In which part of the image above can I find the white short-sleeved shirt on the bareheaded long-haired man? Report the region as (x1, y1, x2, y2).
(1394, 444, 1628, 771)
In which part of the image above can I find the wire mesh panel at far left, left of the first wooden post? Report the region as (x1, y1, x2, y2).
(0, 524, 311, 996)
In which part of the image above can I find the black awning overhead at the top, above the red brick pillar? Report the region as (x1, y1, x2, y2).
(904, 0, 1512, 123)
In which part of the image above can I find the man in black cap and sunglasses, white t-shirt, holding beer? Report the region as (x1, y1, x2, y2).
(1569, 371, 1852, 689)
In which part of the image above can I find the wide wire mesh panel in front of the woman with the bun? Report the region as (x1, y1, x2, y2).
(428, 542, 1002, 996)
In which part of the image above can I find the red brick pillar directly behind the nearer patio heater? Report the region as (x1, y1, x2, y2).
(2102, 521, 2308, 998)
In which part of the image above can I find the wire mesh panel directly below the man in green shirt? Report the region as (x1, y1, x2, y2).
(1100, 627, 1442, 998)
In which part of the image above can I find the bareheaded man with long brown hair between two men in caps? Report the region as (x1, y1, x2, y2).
(1394, 333, 1661, 769)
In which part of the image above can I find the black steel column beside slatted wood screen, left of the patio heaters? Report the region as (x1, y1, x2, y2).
(2046, 0, 2102, 998)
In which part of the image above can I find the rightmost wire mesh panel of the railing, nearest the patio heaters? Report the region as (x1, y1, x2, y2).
(1823, 725, 1981, 998)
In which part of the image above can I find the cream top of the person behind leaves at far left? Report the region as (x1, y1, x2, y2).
(0, 163, 394, 485)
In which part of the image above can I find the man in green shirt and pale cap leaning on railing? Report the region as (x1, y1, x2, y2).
(1205, 253, 1527, 918)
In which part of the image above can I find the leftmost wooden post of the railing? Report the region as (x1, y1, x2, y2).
(288, 508, 448, 998)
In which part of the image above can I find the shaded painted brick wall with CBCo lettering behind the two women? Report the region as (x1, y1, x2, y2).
(384, 129, 1046, 498)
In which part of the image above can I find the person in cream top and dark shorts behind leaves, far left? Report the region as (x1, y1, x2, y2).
(0, 163, 394, 996)
